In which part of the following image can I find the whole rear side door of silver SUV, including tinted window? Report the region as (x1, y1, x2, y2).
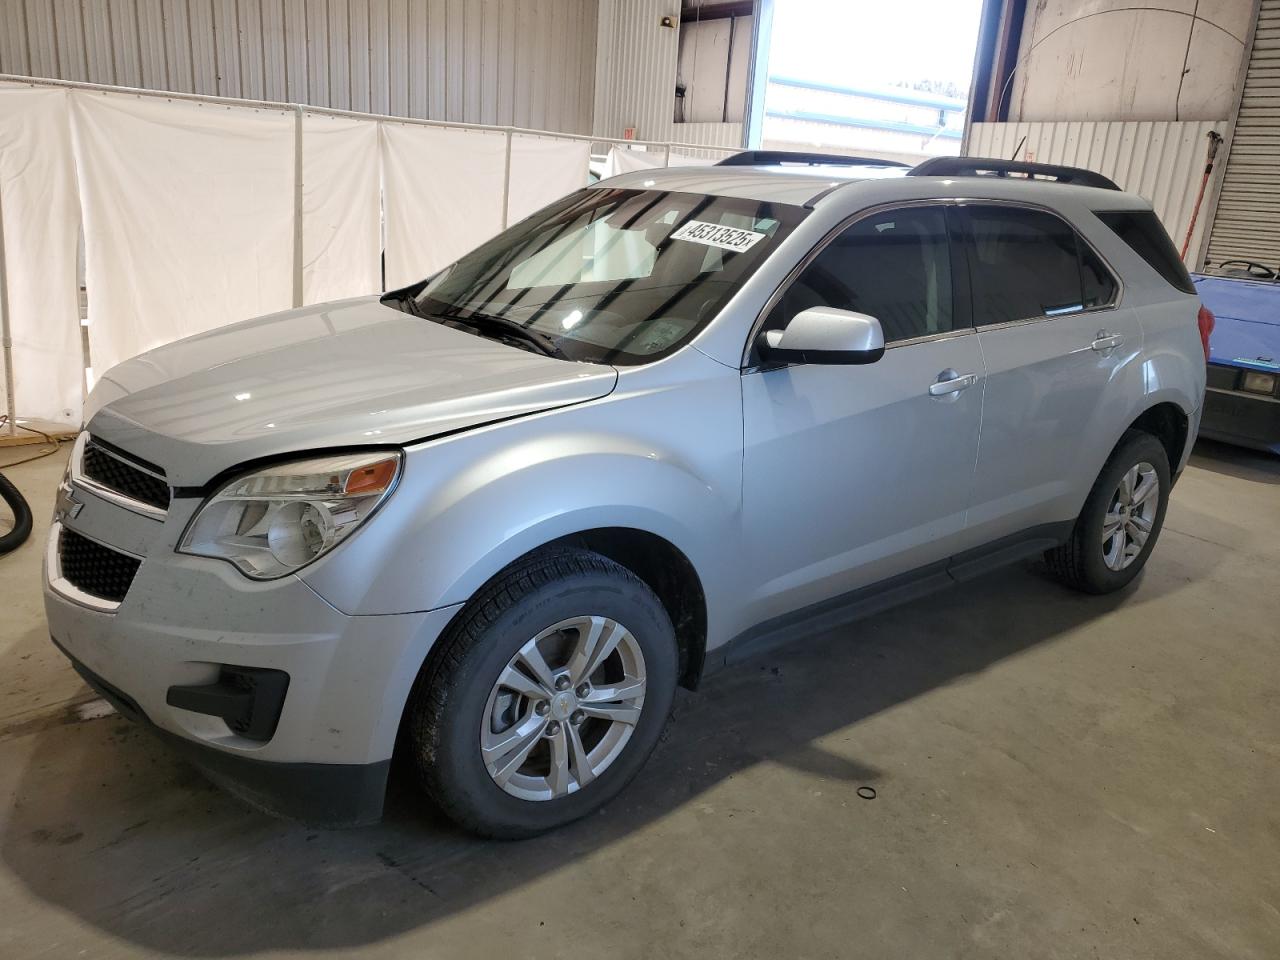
(954, 202, 1143, 544)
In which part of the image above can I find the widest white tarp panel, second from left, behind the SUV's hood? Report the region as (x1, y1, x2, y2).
(72, 91, 294, 375)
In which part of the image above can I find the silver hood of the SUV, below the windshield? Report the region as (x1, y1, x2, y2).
(86, 297, 618, 486)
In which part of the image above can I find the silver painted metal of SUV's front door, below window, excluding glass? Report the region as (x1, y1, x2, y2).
(736, 333, 983, 630)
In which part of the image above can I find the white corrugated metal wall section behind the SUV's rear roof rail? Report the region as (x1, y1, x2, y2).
(964, 120, 1226, 262)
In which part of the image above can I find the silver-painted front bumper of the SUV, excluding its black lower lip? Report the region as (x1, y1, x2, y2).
(45, 489, 456, 763)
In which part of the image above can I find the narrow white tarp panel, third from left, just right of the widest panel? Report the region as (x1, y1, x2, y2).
(302, 113, 381, 303)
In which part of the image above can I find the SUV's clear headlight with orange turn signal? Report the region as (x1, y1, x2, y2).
(178, 451, 401, 580)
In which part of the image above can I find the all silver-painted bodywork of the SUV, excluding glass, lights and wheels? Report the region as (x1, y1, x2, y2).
(37, 168, 1204, 778)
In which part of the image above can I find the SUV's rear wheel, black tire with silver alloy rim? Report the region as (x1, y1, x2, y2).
(1044, 430, 1171, 594)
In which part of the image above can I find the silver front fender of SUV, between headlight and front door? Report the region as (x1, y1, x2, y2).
(302, 361, 742, 626)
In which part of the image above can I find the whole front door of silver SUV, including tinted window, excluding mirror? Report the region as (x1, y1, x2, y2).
(742, 205, 986, 632)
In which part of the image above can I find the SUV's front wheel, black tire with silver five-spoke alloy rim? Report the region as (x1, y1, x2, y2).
(407, 549, 678, 838)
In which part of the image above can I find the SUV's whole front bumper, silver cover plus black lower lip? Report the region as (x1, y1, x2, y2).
(45, 463, 457, 823)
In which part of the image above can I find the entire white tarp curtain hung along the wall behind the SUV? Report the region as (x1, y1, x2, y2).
(0, 83, 629, 422)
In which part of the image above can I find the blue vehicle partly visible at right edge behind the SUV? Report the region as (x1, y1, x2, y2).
(1192, 260, 1280, 453)
